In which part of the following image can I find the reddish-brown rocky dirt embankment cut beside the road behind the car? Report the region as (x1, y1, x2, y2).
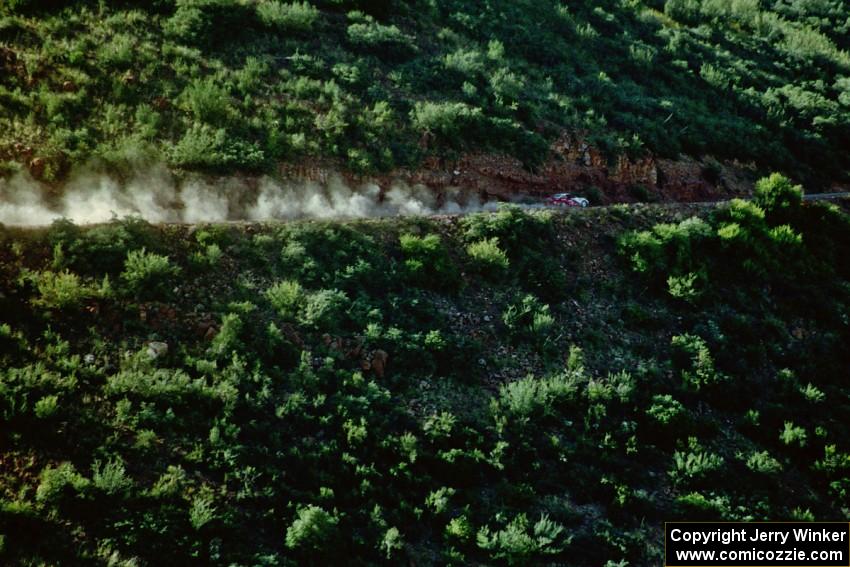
(279, 136, 757, 204)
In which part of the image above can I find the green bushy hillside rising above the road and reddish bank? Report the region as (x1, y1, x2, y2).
(0, 0, 850, 182)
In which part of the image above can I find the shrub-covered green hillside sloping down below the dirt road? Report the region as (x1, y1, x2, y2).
(0, 176, 850, 566)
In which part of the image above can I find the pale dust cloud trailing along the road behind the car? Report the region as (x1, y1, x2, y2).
(0, 166, 495, 226)
